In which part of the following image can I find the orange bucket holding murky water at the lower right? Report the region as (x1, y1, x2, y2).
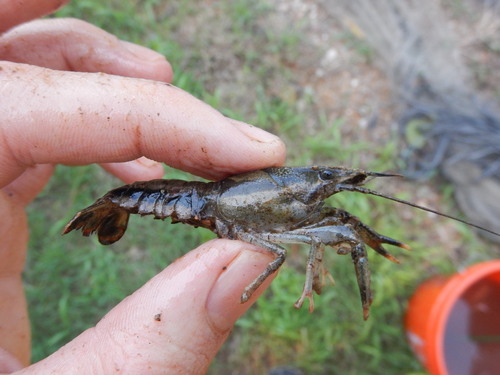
(405, 260, 500, 375)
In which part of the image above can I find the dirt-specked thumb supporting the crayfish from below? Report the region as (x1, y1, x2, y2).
(23, 240, 278, 375)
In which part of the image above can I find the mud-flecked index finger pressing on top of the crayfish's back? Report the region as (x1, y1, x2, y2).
(0, 62, 285, 186)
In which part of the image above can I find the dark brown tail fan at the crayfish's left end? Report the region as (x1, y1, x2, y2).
(62, 200, 129, 245)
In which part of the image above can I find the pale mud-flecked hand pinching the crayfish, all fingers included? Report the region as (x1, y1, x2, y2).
(0, 0, 285, 375)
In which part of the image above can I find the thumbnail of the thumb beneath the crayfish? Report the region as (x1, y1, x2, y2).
(207, 250, 272, 331)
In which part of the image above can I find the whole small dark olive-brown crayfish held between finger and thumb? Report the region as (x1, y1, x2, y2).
(63, 167, 496, 319)
